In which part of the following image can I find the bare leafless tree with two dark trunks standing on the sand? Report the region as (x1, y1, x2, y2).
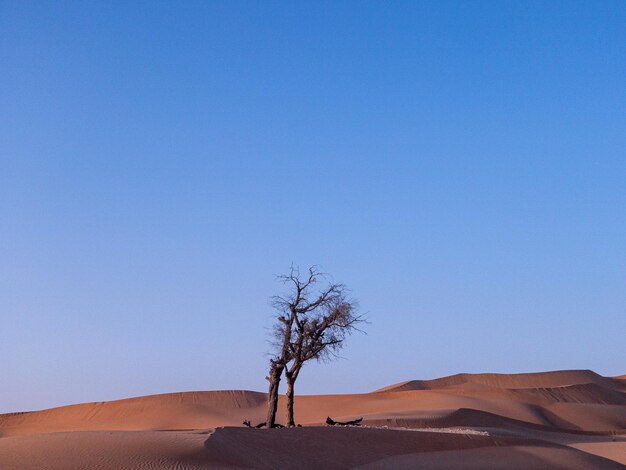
(267, 266, 364, 427)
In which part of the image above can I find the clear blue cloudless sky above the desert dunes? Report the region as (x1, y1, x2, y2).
(0, 0, 626, 411)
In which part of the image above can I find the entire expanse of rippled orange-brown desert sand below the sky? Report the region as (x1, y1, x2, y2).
(0, 370, 626, 470)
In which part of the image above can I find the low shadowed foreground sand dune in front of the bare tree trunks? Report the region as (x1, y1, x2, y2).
(0, 427, 624, 470)
